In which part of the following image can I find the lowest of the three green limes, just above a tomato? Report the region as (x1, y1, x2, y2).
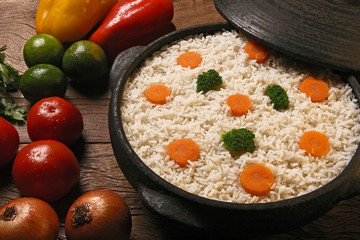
(19, 64, 67, 103)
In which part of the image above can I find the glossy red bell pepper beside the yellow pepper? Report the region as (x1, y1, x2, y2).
(89, 0, 175, 62)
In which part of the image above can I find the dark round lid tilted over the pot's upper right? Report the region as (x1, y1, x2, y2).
(214, 0, 360, 72)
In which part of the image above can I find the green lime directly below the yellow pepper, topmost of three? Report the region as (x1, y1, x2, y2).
(23, 33, 64, 67)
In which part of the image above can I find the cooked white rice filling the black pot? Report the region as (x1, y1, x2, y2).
(121, 31, 360, 203)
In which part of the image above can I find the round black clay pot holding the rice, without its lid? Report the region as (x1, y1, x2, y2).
(109, 23, 360, 232)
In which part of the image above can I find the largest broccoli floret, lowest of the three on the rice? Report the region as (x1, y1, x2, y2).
(221, 128, 255, 153)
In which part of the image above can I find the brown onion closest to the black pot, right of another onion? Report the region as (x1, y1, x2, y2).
(65, 190, 132, 240)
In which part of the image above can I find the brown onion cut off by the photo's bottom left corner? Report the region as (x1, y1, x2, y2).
(0, 197, 60, 240)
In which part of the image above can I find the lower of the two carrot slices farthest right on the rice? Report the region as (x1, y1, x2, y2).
(299, 131, 329, 157)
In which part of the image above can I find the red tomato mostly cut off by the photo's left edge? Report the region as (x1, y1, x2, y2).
(0, 117, 20, 167)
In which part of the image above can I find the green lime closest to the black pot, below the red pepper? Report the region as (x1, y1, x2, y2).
(62, 40, 109, 84)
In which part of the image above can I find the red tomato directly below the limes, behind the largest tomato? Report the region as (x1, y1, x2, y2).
(27, 97, 84, 146)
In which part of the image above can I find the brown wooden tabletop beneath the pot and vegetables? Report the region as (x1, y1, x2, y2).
(0, 0, 360, 240)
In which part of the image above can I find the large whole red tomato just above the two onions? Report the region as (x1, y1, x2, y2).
(12, 140, 80, 202)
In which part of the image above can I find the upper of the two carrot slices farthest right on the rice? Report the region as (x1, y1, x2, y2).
(300, 77, 329, 102)
